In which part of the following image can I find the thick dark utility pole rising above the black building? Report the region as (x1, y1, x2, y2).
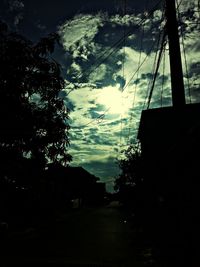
(165, 0, 185, 109)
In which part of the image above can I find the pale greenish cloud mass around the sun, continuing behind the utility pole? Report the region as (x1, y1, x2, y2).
(59, 6, 200, 191)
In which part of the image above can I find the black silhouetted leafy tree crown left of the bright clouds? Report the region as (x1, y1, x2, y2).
(0, 22, 71, 186)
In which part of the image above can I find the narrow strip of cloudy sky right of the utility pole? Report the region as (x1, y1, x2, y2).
(175, 0, 200, 103)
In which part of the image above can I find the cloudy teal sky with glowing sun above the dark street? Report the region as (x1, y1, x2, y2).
(0, 0, 200, 191)
